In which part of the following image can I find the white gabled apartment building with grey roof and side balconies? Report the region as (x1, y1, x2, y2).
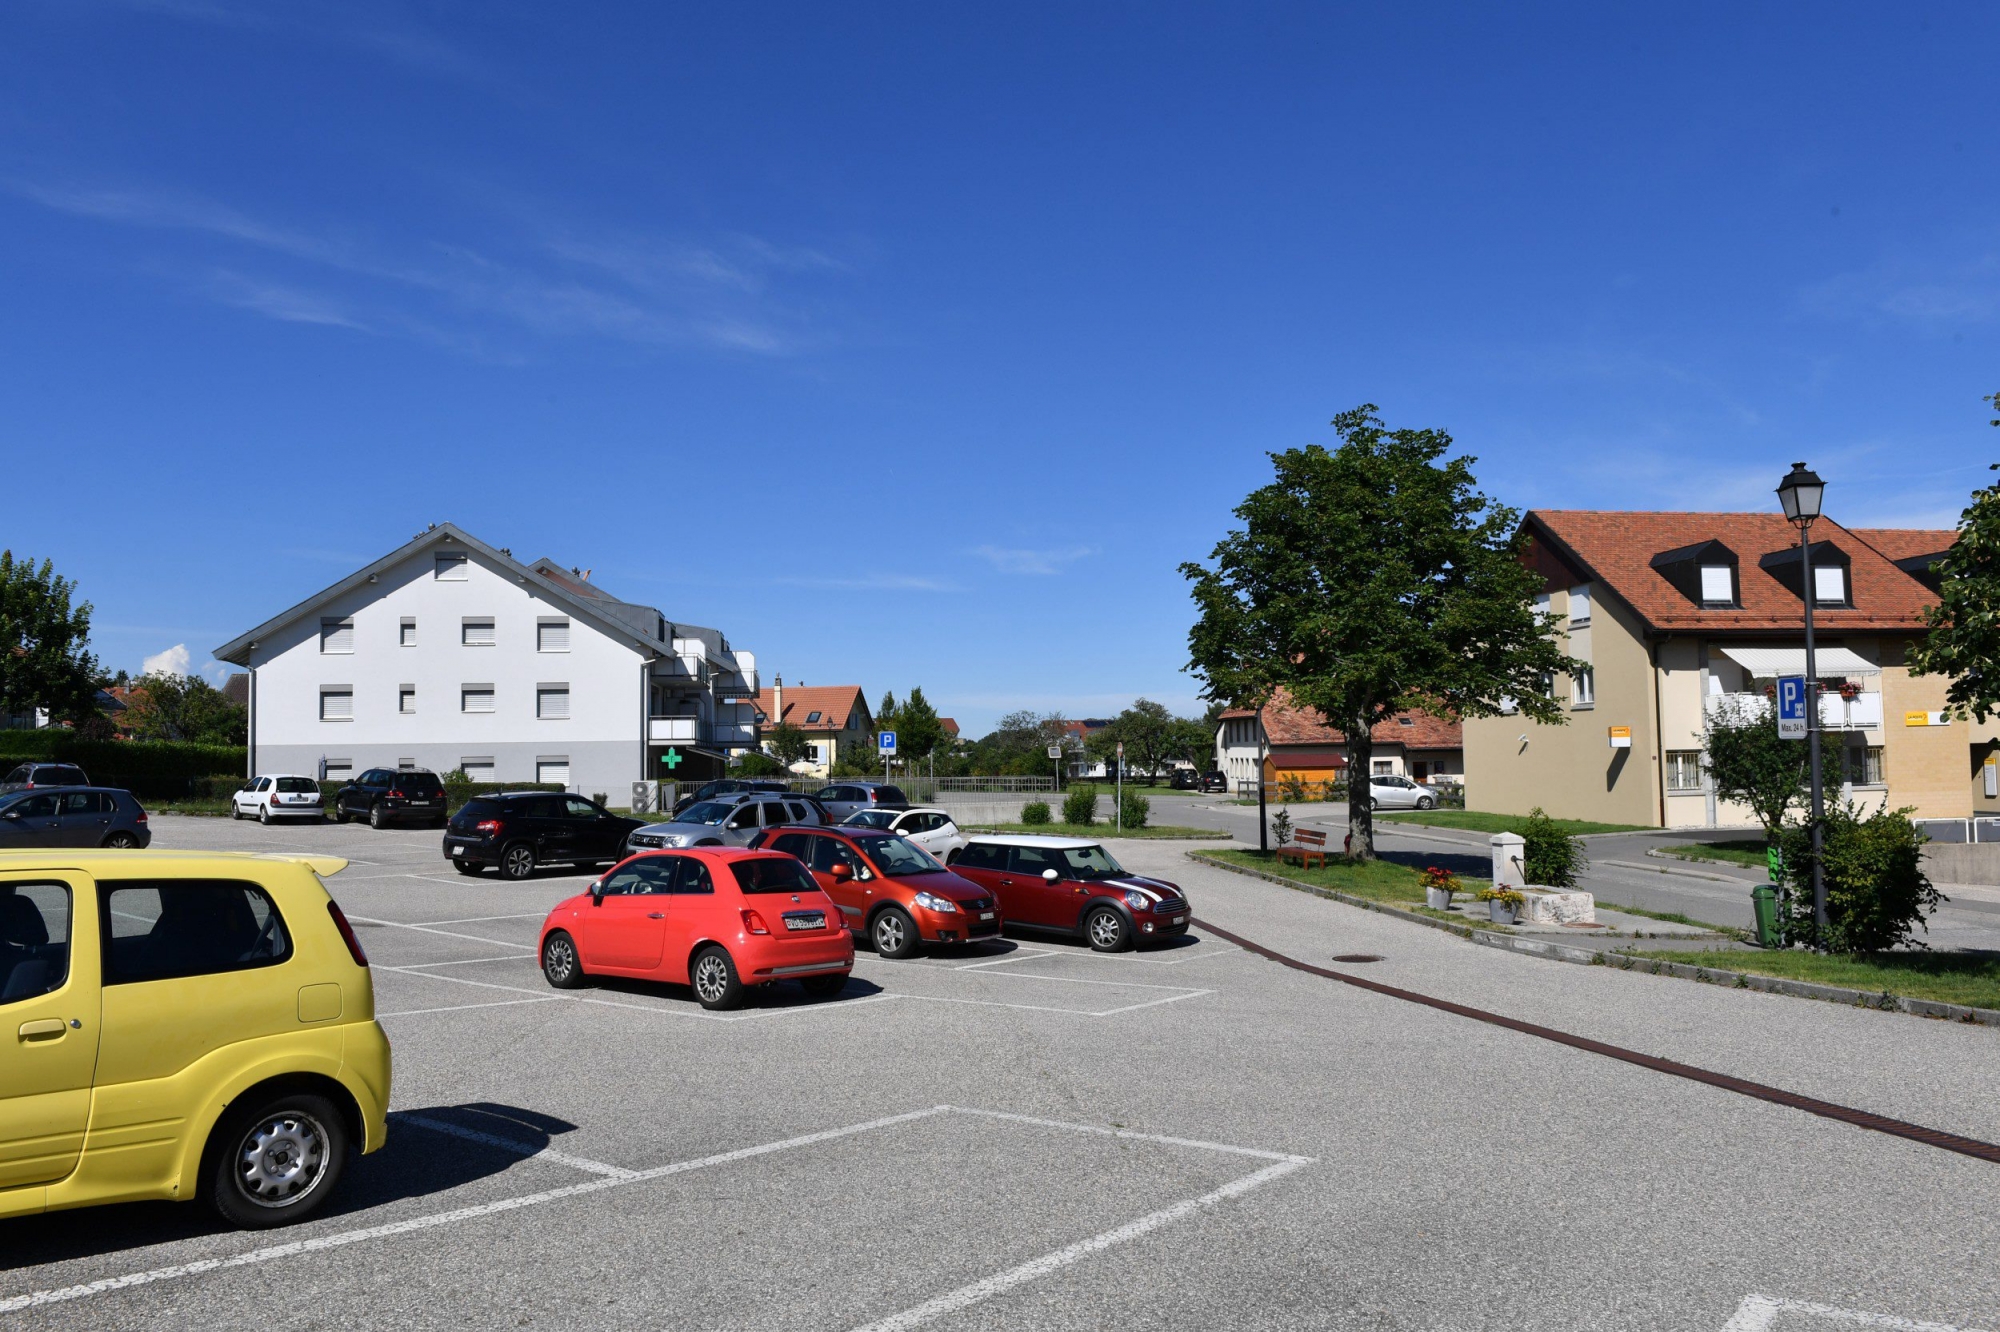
(216, 522, 758, 804)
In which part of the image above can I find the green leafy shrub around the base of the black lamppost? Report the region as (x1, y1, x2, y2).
(1778, 804, 1946, 952)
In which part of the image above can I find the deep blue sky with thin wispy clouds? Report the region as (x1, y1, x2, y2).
(0, 0, 2000, 734)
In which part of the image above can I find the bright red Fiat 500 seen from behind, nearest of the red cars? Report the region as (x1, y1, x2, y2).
(542, 848, 854, 1008)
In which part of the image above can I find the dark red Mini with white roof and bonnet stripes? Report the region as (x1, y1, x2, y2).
(952, 836, 1190, 952)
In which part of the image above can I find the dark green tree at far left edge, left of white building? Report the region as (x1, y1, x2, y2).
(0, 550, 98, 722)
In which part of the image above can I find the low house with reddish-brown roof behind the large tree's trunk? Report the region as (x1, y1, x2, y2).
(1216, 688, 1466, 788)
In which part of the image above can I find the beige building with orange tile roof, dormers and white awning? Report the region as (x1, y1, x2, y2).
(1464, 510, 1960, 828)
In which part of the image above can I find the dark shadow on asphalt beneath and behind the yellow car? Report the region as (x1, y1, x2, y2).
(0, 1102, 576, 1272)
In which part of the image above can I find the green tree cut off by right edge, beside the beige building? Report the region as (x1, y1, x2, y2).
(1910, 462, 2000, 724)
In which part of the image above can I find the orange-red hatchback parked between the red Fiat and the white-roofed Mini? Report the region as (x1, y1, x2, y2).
(764, 828, 1000, 958)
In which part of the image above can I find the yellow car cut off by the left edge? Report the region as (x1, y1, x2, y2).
(0, 848, 390, 1226)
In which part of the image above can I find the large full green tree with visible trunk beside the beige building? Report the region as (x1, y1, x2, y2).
(1182, 404, 1584, 860)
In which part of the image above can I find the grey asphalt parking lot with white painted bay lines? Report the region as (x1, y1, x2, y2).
(0, 816, 2000, 1332)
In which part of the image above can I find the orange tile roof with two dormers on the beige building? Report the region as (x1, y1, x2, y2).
(1522, 508, 1936, 634)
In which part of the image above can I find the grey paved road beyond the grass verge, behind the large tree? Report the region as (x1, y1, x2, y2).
(1154, 800, 2000, 950)
